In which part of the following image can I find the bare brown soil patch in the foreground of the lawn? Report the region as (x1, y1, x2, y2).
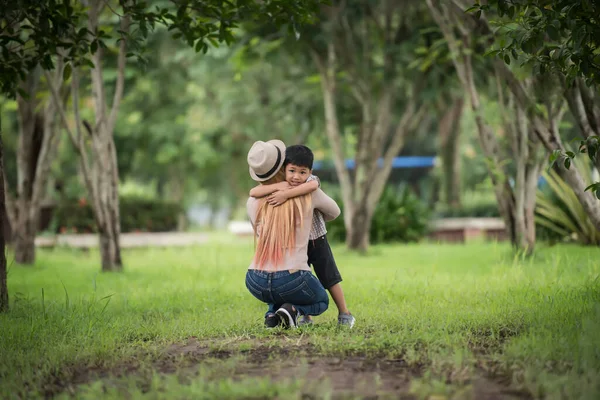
(43, 338, 528, 400)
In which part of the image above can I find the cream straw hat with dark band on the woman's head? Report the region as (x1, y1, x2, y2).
(248, 140, 285, 182)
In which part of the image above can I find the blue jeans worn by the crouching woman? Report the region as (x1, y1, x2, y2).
(246, 269, 329, 315)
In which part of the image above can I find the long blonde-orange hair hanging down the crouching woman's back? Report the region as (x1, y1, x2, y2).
(254, 168, 311, 269)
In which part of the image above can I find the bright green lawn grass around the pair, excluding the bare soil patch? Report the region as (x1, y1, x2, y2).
(0, 236, 600, 399)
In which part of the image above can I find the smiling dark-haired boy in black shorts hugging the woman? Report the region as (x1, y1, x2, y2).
(250, 145, 356, 328)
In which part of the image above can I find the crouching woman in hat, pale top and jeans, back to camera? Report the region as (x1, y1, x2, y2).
(246, 140, 340, 328)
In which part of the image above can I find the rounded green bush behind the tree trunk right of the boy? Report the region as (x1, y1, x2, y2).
(327, 186, 430, 244)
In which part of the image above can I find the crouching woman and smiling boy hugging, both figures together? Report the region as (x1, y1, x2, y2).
(246, 140, 355, 328)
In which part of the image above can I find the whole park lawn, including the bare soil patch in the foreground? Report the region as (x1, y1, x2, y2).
(0, 237, 600, 399)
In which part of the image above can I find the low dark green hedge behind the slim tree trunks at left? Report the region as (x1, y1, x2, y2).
(52, 196, 182, 233)
